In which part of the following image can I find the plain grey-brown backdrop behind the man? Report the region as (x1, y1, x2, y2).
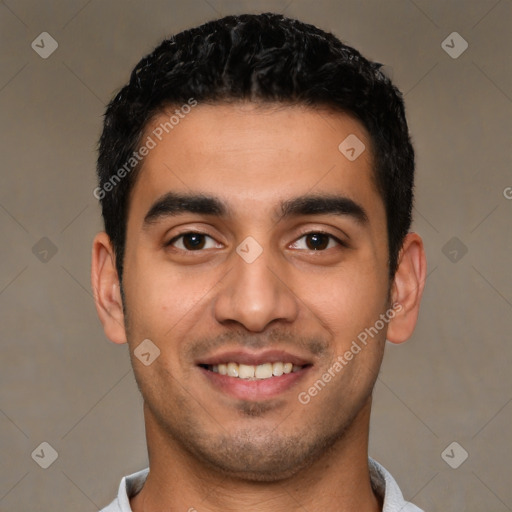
(0, 0, 512, 512)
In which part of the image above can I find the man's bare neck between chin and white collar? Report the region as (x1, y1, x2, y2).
(131, 399, 382, 512)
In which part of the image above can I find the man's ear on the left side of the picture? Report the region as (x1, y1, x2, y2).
(91, 232, 126, 343)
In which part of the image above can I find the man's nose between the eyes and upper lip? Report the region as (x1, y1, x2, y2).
(214, 243, 299, 332)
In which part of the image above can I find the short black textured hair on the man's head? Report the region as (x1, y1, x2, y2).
(94, 13, 414, 280)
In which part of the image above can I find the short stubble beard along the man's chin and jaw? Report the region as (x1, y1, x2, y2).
(142, 380, 371, 482)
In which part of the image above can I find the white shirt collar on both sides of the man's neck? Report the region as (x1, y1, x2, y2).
(100, 458, 423, 512)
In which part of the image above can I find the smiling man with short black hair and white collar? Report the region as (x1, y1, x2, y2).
(92, 14, 426, 512)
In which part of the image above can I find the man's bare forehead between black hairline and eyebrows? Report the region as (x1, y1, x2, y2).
(130, 103, 383, 225)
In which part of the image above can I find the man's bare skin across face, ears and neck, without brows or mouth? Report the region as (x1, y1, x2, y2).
(92, 103, 426, 512)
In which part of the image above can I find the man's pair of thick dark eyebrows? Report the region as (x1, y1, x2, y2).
(144, 192, 368, 227)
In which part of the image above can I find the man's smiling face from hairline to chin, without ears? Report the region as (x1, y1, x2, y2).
(123, 104, 389, 480)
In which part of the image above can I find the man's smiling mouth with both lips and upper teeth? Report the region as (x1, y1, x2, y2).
(197, 351, 313, 401)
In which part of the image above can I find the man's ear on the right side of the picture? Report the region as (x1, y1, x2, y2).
(386, 233, 427, 343)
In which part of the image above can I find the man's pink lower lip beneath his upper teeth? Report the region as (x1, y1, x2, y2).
(199, 366, 311, 401)
